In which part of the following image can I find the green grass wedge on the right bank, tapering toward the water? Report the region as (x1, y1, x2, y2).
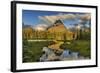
(60, 40, 91, 58)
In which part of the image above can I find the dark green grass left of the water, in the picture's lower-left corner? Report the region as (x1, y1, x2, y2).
(23, 40, 54, 63)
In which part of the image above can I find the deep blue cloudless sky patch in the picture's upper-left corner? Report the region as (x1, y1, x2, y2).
(22, 10, 61, 25)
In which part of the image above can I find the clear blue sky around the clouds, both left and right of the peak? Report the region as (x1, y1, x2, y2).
(22, 10, 90, 26)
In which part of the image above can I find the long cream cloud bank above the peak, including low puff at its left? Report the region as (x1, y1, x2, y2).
(34, 13, 91, 30)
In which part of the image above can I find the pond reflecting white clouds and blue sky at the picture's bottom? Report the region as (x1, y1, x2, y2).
(40, 47, 85, 62)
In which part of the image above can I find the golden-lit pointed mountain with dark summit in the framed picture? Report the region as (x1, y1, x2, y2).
(47, 20, 76, 40)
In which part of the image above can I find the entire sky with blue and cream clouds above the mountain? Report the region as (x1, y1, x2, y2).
(22, 10, 90, 30)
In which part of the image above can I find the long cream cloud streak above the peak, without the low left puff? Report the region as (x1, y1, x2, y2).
(39, 13, 91, 24)
